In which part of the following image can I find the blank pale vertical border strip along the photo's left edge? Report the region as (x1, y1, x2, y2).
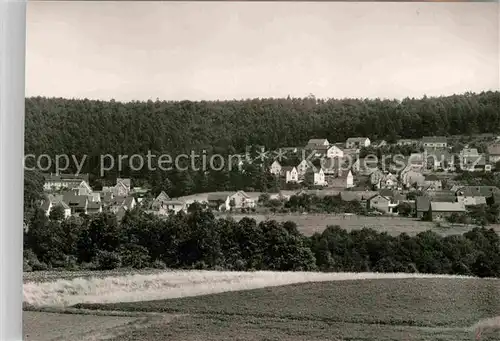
(0, 0, 26, 341)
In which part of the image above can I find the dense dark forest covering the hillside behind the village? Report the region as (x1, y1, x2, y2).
(25, 91, 500, 190)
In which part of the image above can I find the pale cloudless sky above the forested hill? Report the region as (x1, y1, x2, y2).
(26, 1, 500, 101)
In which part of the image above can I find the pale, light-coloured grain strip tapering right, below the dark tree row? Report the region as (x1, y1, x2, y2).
(23, 271, 470, 307)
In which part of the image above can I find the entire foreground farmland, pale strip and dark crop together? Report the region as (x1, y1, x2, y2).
(24, 271, 500, 341)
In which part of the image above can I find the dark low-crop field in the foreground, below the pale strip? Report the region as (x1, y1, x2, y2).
(73, 278, 500, 341)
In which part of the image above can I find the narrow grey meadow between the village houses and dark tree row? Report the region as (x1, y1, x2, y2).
(220, 214, 500, 236)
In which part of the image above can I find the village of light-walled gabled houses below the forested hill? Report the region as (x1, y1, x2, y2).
(41, 136, 500, 221)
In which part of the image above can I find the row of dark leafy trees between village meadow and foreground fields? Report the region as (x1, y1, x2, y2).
(24, 205, 500, 277)
